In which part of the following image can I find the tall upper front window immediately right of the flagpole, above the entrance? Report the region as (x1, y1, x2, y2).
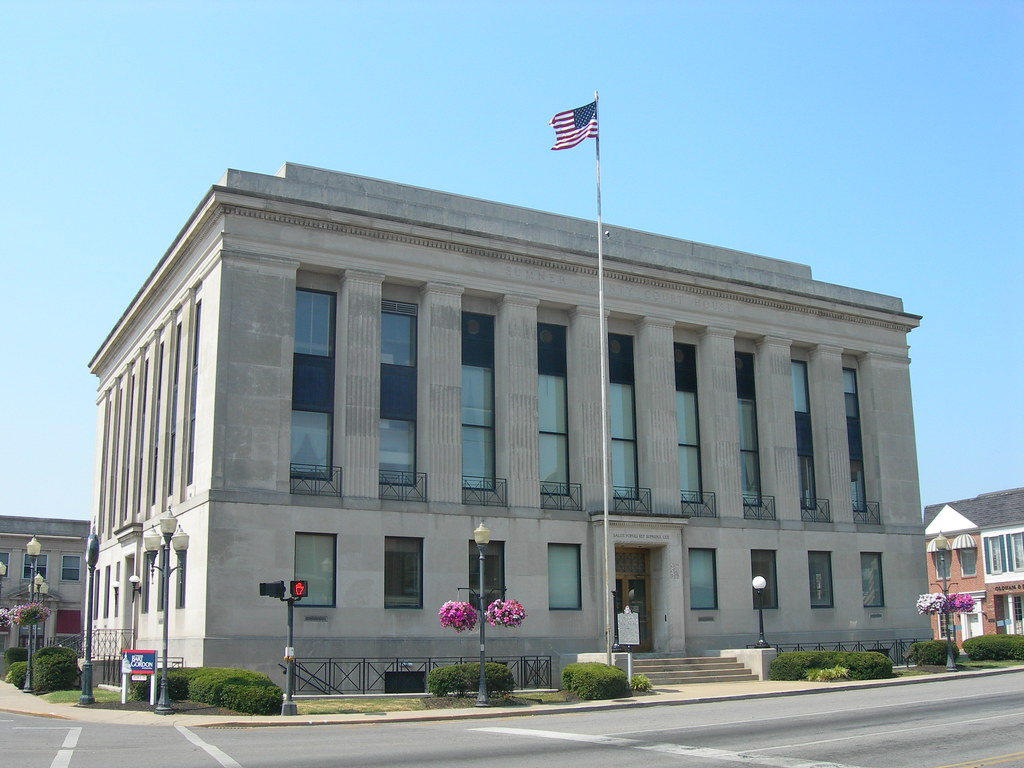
(608, 334, 639, 494)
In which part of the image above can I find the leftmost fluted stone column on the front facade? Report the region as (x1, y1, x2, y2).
(335, 269, 384, 499)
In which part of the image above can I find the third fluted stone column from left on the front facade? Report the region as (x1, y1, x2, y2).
(495, 296, 541, 508)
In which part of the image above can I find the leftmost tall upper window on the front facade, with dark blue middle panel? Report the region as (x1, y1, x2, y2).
(292, 290, 335, 475)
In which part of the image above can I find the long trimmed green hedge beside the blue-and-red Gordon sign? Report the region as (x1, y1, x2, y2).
(130, 667, 284, 715)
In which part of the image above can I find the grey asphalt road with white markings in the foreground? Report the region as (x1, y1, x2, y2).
(0, 674, 1024, 768)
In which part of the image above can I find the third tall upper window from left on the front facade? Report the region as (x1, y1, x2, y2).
(462, 312, 495, 483)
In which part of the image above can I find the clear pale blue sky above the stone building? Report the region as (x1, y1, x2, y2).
(0, 0, 1024, 518)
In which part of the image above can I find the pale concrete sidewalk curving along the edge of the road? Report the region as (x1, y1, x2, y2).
(0, 667, 1024, 728)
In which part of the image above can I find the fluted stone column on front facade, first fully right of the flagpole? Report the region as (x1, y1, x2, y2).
(633, 317, 679, 514)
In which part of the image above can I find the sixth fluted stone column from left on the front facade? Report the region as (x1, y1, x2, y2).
(697, 328, 743, 517)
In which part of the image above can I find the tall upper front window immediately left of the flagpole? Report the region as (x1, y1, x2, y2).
(537, 324, 569, 493)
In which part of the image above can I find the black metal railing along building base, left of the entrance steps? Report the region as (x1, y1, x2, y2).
(279, 655, 551, 695)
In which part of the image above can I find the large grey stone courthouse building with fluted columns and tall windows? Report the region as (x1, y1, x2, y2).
(90, 164, 928, 669)
